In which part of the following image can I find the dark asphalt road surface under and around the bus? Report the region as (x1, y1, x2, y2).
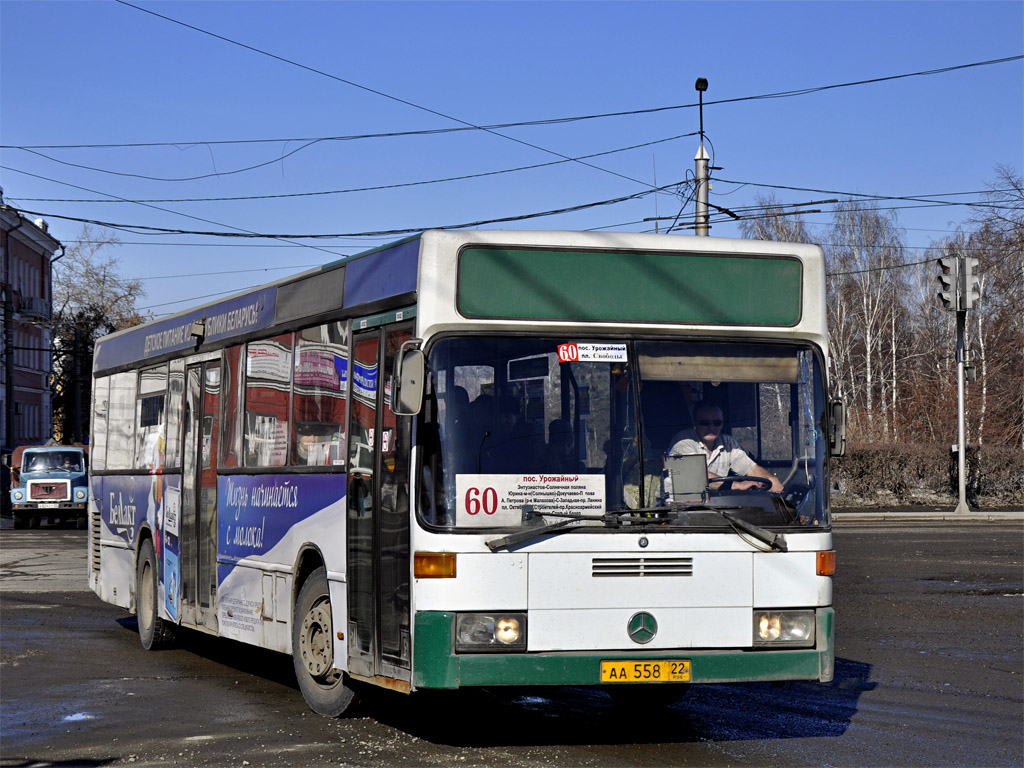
(0, 516, 1024, 768)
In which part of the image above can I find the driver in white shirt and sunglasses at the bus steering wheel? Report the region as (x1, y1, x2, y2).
(668, 402, 782, 494)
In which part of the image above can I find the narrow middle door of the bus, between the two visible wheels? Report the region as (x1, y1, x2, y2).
(180, 359, 220, 630)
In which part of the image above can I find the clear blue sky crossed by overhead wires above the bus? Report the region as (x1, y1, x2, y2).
(0, 0, 1024, 315)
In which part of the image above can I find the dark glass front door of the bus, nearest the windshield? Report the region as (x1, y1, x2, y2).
(346, 323, 412, 681)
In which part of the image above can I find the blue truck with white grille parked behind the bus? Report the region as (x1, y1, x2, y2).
(9, 445, 89, 528)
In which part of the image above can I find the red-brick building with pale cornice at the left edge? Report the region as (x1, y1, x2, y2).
(0, 190, 62, 450)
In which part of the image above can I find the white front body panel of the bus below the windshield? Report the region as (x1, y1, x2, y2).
(414, 530, 833, 651)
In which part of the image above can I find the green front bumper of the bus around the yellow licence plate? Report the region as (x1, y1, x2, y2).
(413, 608, 834, 688)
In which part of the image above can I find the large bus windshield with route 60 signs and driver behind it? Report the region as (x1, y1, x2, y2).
(419, 336, 828, 531)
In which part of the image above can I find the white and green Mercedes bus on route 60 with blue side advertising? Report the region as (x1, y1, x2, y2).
(89, 230, 844, 716)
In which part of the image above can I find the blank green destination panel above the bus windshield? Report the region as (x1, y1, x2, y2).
(457, 248, 803, 327)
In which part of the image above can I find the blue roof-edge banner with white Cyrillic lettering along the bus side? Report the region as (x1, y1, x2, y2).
(93, 288, 278, 370)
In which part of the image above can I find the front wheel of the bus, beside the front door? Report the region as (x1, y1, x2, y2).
(292, 566, 355, 718)
